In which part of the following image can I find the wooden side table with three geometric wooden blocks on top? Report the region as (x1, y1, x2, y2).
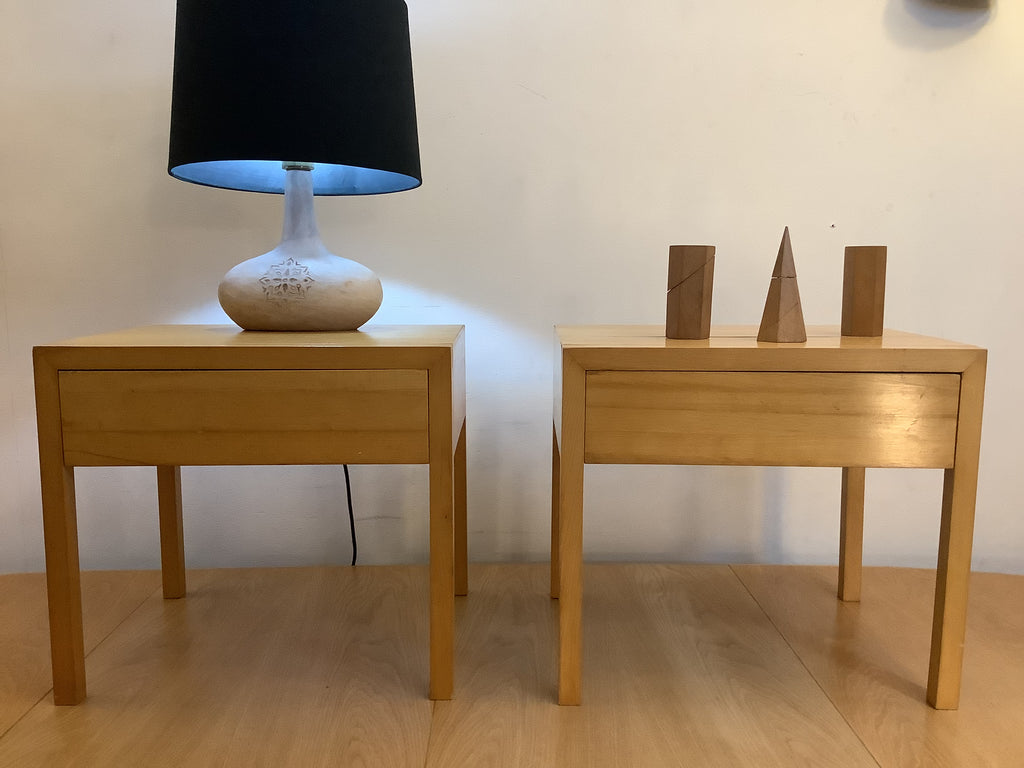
(551, 326, 987, 710)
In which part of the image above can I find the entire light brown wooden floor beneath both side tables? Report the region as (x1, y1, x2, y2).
(0, 564, 1024, 768)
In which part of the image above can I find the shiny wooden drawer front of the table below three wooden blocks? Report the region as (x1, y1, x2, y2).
(584, 371, 959, 467)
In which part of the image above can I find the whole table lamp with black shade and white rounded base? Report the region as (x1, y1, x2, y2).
(168, 0, 422, 331)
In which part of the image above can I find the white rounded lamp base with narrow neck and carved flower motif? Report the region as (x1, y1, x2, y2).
(217, 169, 384, 331)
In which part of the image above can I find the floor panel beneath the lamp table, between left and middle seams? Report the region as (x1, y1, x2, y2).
(0, 566, 432, 768)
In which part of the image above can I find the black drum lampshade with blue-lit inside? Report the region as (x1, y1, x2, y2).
(167, 0, 422, 195)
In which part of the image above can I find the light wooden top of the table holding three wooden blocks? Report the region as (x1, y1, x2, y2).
(555, 326, 986, 372)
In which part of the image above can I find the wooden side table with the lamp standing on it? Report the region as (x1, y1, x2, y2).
(34, 326, 467, 705)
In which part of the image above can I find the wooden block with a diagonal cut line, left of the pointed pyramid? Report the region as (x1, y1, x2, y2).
(665, 246, 715, 339)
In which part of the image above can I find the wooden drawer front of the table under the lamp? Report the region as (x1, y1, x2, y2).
(59, 370, 428, 466)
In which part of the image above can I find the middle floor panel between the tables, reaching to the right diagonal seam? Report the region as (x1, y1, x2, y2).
(427, 564, 876, 768)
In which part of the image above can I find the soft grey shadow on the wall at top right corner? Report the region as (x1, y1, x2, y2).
(885, 0, 995, 49)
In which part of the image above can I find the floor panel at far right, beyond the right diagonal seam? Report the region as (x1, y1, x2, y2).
(733, 565, 1024, 768)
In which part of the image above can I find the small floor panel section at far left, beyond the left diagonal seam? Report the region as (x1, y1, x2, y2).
(0, 570, 160, 736)
